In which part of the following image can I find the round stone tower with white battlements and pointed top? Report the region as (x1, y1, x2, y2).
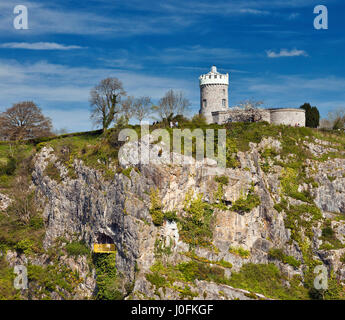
(199, 66, 229, 123)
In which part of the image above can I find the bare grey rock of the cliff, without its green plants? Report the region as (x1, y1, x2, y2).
(25, 132, 345, 299)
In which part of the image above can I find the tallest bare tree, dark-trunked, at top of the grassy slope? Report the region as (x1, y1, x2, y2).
(90, 78, 126, 131)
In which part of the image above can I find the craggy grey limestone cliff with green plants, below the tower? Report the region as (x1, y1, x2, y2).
(0, 124, 345, 299)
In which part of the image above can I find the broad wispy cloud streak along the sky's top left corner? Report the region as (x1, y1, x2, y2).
(0, 0, 195, 37)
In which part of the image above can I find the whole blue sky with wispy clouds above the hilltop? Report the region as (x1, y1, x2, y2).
(0, 0, 345, 132)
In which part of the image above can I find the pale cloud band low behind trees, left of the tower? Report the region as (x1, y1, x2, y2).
(0, 60, 198, 131)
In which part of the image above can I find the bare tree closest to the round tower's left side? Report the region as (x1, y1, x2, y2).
(154, 89, 190, 120)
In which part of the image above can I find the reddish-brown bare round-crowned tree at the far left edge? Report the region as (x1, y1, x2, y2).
(0, 101, 52, 140)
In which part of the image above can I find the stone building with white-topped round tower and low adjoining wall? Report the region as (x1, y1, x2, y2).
(199, 66, 305, 127)
